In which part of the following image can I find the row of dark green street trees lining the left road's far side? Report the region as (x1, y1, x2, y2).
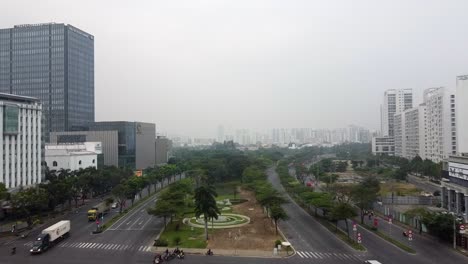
(0, 164, 184, 226)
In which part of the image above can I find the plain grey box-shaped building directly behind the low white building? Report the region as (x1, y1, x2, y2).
(48, 130, 119, 167)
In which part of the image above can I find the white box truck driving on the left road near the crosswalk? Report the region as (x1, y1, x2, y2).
(29, 220, 70, 254)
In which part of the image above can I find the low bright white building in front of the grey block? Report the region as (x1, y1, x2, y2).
(45, 142, 102, 171)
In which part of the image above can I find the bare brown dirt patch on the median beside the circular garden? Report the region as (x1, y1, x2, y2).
(207, 190, 278, 251)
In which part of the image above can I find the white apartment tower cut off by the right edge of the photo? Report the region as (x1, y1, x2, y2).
(458, 75, 468, 154)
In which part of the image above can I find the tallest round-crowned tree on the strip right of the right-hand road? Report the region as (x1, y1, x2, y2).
(351, 177, 380, 224)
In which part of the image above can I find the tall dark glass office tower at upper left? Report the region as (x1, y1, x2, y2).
(0, 23, 94, 140)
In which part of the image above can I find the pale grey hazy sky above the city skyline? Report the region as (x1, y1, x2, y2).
(0, 0, 468, 137)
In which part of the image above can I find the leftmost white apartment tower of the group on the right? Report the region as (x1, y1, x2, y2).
(381, 89, 413, 137)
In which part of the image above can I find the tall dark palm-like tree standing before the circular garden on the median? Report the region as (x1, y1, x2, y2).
(194, 185, 221, 240)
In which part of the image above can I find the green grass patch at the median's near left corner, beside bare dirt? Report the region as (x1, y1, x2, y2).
(159, 221, 206, 248)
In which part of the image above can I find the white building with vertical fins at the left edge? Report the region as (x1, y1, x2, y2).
(0, 93, 42, 189)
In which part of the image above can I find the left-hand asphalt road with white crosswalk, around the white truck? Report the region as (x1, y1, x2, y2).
(0, 174, 182, 263)
